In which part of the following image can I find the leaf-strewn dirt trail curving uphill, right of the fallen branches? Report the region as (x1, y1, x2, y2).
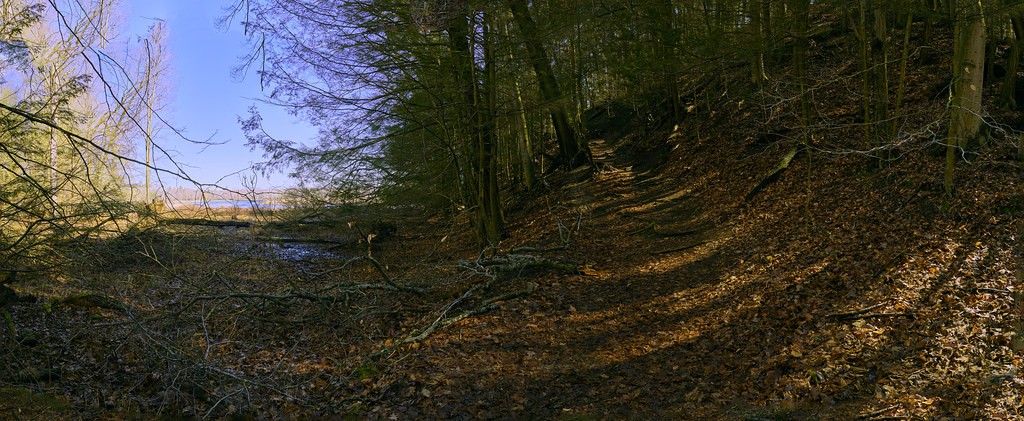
(387, 137, 757, 419)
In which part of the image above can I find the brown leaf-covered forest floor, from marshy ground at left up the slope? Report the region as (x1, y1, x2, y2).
(0, 62, 1024, 420)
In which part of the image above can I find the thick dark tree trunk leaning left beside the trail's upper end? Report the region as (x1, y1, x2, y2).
(507, 0, 587, 168)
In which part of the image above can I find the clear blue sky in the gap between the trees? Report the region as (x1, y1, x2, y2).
(124, 0, 316, 188)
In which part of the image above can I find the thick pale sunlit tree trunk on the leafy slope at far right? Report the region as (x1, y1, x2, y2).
(944, 3, 985, 197)
